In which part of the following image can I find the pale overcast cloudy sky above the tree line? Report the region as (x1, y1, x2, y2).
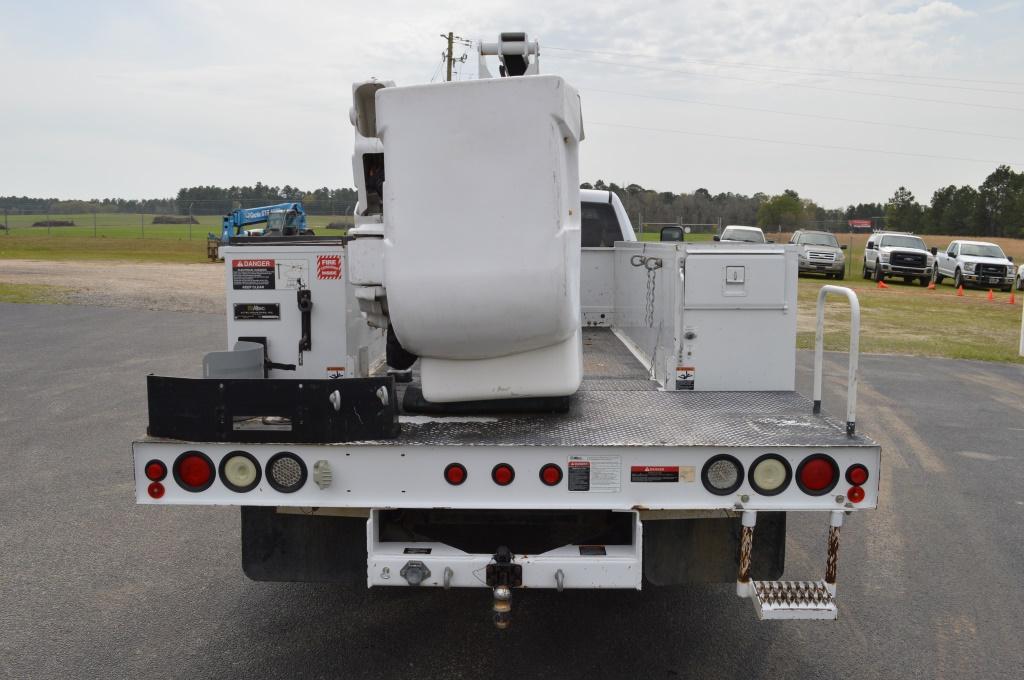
(0, 0, 1024, 207)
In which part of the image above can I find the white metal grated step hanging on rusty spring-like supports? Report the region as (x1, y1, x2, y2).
(736, 510, 843, 621)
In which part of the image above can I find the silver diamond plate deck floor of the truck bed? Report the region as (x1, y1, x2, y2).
(360, 328, 876, 448)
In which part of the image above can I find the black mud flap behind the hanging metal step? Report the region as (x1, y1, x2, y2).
(643, 512, 785, 586)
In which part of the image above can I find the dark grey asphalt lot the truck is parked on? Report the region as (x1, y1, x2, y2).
(0, 304, 1024, 680)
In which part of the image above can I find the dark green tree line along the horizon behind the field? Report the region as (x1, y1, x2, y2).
(0, 165, 1024, 238)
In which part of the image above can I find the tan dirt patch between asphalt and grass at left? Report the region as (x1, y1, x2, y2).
(0, 260, 224, 314)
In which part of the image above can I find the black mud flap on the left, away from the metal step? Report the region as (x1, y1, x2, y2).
(242, 506, 367, 587)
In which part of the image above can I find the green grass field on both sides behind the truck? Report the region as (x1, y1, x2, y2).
(0, 213, 1024, 363)
